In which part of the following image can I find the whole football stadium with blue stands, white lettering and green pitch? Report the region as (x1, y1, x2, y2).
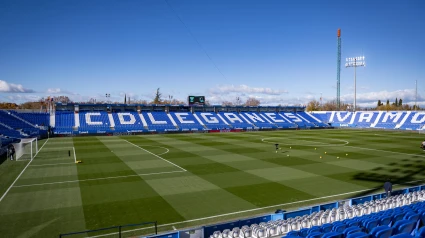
(0, 108, 425, 238)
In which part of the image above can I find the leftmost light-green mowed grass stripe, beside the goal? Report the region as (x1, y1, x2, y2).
(0, 138, 86, 237)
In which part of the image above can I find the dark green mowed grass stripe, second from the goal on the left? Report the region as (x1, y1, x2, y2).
(74, 137, 184, 229)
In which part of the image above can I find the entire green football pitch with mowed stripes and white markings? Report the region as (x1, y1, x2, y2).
(0, 130, 425, 237)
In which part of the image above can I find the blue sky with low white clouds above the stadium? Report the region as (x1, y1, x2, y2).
(0, 0, 425, 106)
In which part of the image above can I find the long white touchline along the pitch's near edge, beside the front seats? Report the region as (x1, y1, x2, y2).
(92, 179, 425, 237)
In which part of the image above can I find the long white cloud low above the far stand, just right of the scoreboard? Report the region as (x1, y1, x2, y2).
(209, 84, 288, 95)
